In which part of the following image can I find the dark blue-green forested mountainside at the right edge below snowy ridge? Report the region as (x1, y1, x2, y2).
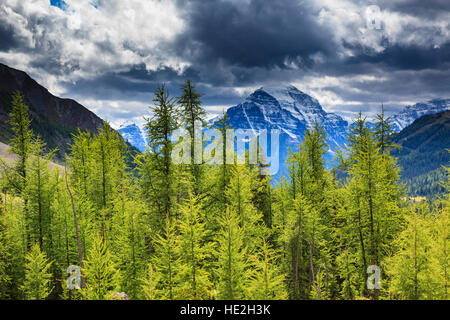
(393, 111, 450, 196)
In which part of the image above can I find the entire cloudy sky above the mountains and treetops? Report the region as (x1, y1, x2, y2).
(0, 0, 450, 126)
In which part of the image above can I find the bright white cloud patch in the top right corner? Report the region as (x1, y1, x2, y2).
(312, 0, 450, 56)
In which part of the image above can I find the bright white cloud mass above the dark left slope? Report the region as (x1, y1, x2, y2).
(0, 0, 188, 91)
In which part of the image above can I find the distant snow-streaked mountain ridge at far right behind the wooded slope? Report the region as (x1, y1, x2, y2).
(392, 99, 450, 132)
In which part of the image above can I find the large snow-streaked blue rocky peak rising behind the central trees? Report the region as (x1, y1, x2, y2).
(221, 86, 348, 174)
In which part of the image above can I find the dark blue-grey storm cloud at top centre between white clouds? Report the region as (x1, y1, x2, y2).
(175, 0, 333, 68)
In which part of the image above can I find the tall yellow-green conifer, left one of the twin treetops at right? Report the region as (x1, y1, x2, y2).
(347, 115, 402, 298)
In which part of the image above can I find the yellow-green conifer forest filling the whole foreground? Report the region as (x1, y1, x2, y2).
(0, 81, 450, 300)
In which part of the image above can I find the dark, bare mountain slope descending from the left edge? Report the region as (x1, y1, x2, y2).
(0, 63, 132, 160)
